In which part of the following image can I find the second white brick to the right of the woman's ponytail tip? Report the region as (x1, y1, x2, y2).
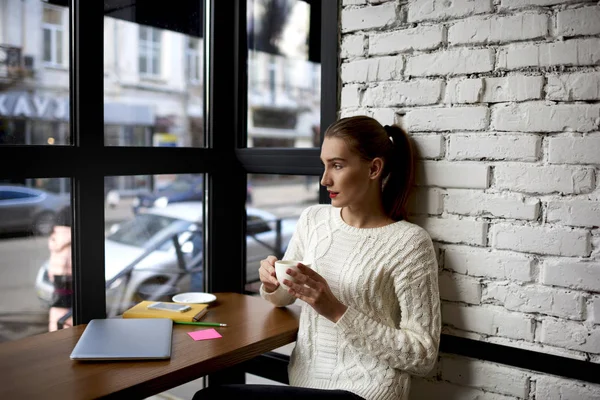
(445, 189, 540, 220)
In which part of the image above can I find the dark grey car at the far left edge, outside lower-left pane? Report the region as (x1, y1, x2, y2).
(0, 185, 70, 236)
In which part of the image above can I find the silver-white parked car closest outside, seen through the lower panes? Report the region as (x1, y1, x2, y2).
(35, 202, 298, 316)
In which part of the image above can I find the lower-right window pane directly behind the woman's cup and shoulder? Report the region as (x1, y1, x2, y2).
(246, 174, 319, 293)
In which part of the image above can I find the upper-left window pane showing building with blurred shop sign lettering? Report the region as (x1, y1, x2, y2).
(0, 0, 71, 145)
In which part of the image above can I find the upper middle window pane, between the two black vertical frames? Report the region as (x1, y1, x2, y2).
(104, 1, 205, 147)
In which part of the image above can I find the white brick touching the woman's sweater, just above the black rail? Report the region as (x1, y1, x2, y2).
(442, 303, 534, 341)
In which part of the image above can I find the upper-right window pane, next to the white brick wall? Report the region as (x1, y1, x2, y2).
(247, 0, 321, 147)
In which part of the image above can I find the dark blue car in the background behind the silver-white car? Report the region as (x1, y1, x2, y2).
(132, 175, 252, 214)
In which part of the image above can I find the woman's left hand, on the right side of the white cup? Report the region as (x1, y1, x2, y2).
(283, 264, 348, 323)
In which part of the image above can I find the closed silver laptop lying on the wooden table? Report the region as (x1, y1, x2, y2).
(71, 318, 173, 361)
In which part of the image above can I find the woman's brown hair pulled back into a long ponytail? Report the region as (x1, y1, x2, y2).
(325, 115, 415, 221)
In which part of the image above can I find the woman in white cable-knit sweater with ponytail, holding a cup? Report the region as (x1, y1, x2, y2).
(197, 116, 441, 400)
